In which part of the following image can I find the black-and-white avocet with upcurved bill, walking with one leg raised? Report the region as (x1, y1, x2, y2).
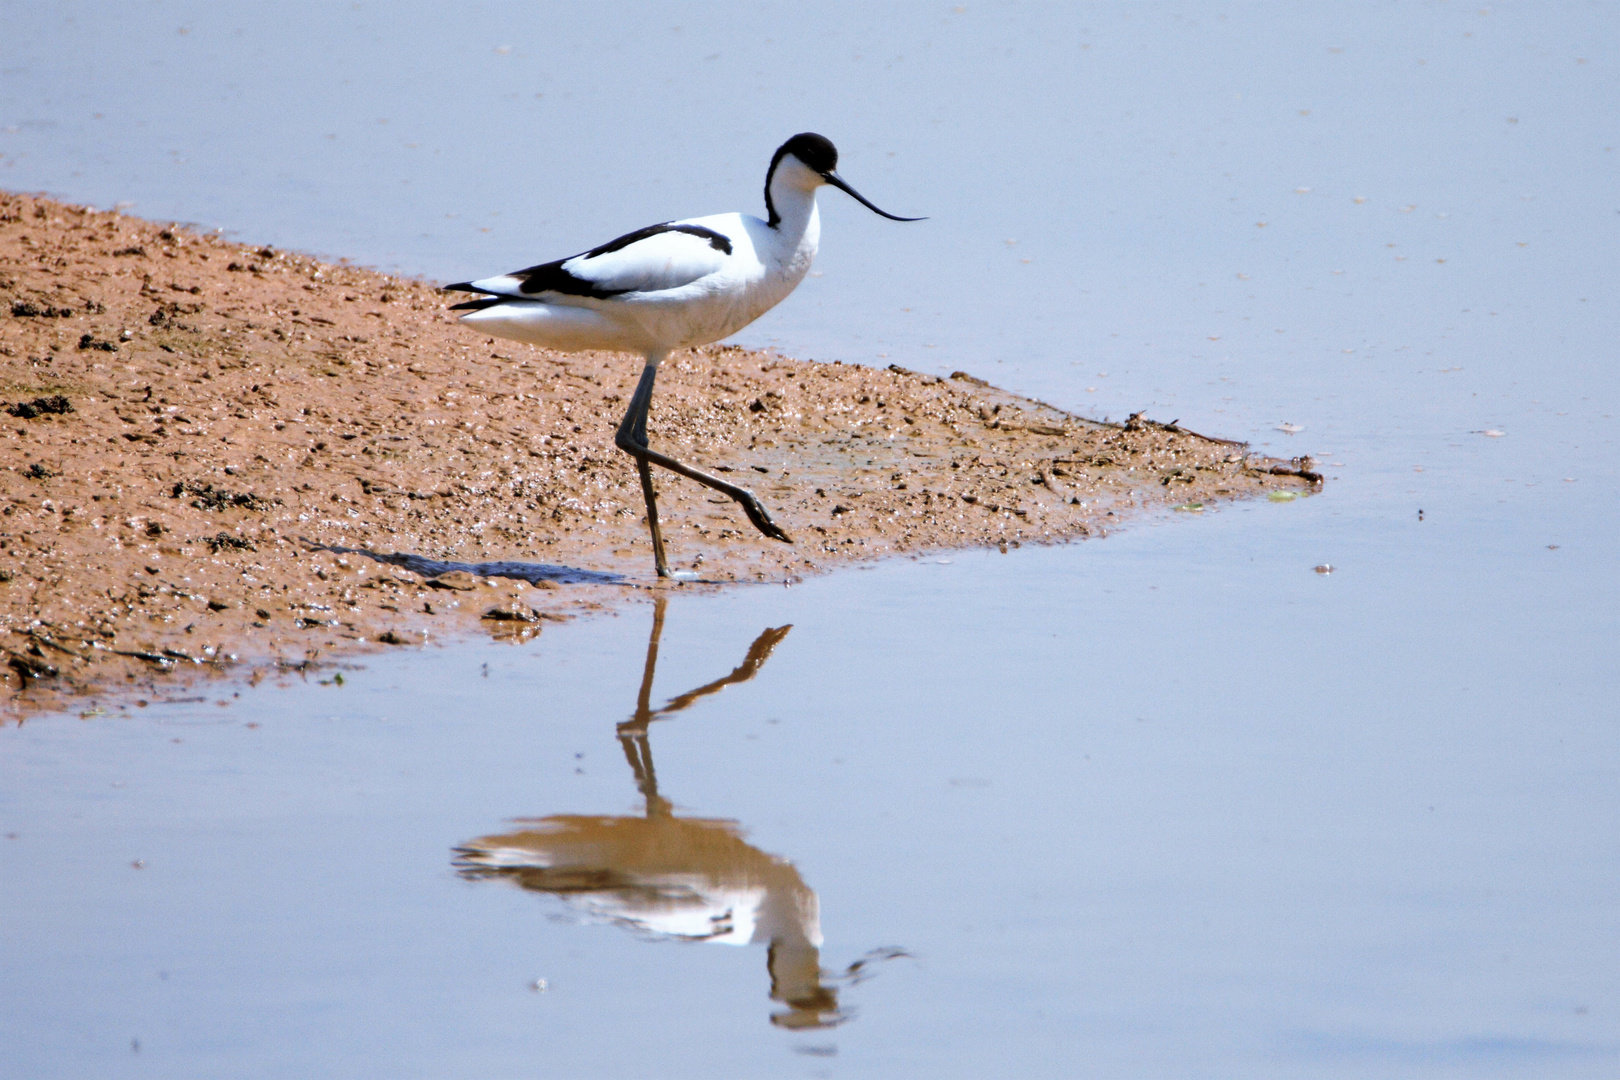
(444, 131, 925, 578)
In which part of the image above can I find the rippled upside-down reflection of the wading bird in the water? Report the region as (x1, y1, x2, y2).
(455, 597, 904, 1028)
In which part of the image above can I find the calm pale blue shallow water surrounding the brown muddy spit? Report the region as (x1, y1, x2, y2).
(0, 3, 1620, 1077)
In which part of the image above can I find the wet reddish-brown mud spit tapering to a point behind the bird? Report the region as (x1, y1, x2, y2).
(0, 194, 1319, 709)
